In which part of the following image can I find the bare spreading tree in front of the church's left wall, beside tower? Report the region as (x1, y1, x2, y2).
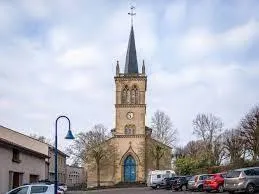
(68, 124, 115, 187)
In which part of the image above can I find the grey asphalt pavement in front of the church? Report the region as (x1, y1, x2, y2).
(66, 187, 221, 194)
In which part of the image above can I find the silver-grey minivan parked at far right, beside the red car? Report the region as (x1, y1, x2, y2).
(224, 167, 259, 194)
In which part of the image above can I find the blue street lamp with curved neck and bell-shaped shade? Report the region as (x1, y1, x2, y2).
(54, 115, 75, 194)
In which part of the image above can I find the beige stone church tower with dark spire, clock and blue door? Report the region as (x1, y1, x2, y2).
(112, 23, 147, 182)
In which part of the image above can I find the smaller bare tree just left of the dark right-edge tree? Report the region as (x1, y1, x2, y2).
(223, 129, 244, 164)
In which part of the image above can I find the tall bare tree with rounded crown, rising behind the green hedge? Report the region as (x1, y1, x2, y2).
(193, 114, 223, 165)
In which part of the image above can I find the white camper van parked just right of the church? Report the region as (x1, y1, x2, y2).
(147, 170, 175, 189)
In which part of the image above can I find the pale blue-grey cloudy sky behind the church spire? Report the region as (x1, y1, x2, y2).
(0, 0, 259, 152)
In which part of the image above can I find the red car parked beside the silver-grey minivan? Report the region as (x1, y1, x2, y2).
(203, 173, 224, 193)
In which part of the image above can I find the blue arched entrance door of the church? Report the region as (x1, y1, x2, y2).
(124, 156, 136, 182)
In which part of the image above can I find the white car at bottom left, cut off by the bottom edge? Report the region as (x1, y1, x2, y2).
(6, 184, 64, 194)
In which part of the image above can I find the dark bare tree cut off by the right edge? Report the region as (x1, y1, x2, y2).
(240, 105, 259, 161)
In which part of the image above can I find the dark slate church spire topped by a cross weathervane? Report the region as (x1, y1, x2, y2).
(124, 6, 138, 74)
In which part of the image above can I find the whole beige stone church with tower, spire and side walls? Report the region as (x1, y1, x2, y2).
(86, 10, 172, 186)
